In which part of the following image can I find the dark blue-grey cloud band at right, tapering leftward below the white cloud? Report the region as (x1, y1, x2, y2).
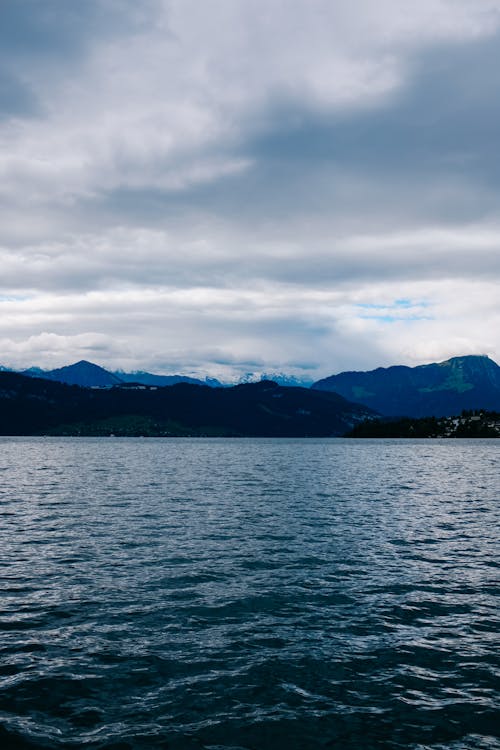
(44, 31, 500, 247)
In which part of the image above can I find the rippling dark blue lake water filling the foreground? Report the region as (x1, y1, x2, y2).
(0, 438, 500, 750)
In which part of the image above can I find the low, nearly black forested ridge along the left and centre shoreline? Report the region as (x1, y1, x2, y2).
(0, 372, 372, 437)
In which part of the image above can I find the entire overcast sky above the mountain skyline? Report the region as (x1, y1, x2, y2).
(0, 0, 500, 380)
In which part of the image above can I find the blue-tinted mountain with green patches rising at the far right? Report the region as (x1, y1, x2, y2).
(312, 356, 500, 417)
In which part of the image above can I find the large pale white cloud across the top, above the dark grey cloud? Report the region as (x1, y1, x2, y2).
(0, 0, 500, 202)
